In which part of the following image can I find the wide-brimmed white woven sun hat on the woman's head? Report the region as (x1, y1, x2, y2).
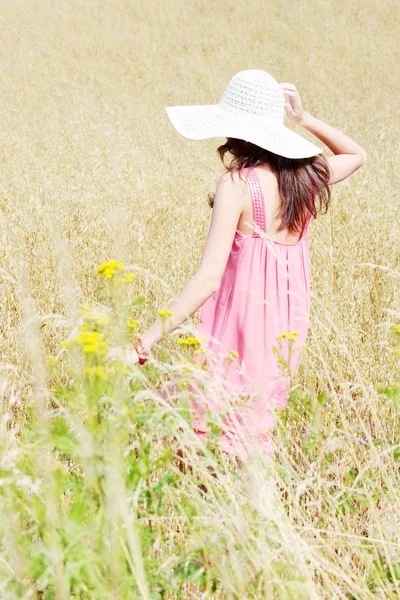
(165, 69, 322, 158)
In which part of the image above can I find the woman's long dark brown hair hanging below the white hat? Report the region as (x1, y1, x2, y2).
(208, 138, 331, 233)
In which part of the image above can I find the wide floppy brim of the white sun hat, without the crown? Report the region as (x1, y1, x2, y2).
(165, 104, 322, 158)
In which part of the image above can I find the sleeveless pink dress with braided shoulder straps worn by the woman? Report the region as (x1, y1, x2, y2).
(192, 167, 311, 457)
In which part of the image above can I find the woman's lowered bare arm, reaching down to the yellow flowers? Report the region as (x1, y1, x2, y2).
(140, 173, 245, 350)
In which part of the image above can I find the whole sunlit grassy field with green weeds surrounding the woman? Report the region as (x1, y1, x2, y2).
(0, 0, 400, 600)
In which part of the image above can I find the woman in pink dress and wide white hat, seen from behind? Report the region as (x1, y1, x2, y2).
(108, 69, 366, 457)
